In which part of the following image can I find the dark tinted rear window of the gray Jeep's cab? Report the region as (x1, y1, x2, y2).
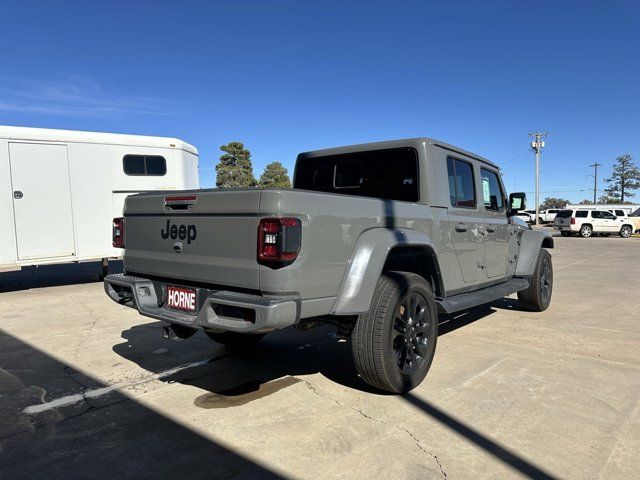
(294, 148, 419, 202)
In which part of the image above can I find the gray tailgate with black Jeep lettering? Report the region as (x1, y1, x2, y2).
(124, 190, 261, 290)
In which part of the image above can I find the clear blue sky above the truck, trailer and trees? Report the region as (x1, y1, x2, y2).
(0, 0, 640, 201)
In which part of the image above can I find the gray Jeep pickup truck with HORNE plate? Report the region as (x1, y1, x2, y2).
(104, 138, 553, 393)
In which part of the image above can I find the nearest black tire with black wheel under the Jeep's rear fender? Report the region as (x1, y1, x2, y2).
(351, 272, 438, 393)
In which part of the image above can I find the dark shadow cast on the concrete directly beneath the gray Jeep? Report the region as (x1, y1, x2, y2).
(113, 306, 504, 400)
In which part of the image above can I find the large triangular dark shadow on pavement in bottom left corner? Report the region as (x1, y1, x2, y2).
(0, 330, 282, 479)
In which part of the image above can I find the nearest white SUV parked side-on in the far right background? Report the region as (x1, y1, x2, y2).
(553, 210, 633, 238)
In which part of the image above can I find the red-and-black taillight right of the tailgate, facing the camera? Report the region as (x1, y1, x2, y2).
(258, 217, 302, 268)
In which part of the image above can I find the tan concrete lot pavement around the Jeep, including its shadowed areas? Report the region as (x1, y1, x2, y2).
(0, 237, 640, 479)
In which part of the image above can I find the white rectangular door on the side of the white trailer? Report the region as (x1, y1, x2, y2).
(9, 143, 75, 260)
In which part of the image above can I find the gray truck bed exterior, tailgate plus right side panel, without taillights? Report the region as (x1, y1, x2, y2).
(124, 189, 430, 313)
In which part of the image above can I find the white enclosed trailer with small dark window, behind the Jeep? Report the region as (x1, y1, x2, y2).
(0, 126, 199, 271)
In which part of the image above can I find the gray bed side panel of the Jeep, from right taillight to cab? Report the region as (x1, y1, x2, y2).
(260, 190, 448, 299)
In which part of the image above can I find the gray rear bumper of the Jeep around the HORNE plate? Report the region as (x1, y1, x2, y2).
(104, 273, 299, 333)
